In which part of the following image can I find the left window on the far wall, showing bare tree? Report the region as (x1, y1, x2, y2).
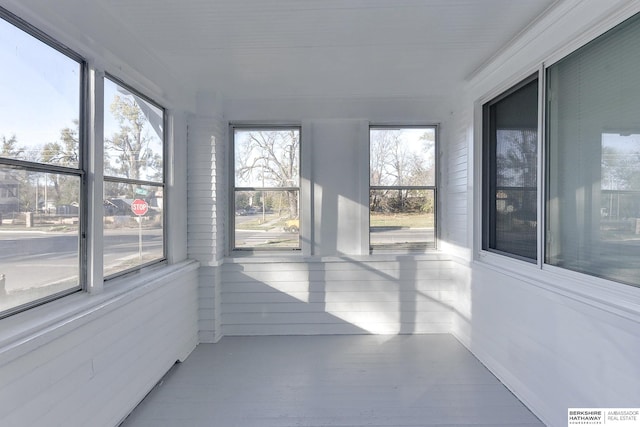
(231, 127, 301, 250)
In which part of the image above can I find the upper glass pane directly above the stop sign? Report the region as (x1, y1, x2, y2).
(104, 79, 164, 182)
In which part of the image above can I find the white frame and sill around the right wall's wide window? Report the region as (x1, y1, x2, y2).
(478, 10, 640, 294)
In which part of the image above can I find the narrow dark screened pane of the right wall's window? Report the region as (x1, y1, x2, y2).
(482, 76, 538, 262)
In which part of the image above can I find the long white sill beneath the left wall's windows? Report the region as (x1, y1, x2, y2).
(0, 261, 198, 365)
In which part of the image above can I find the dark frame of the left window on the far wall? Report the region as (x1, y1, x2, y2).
(227, 123, 305, 255)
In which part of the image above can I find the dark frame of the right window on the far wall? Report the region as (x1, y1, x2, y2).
(367, 123, 440, 254)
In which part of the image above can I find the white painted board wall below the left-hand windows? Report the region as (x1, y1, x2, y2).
(0, 262, 198, 427)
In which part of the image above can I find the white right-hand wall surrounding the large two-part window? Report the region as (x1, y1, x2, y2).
(443, 0, 640, 426)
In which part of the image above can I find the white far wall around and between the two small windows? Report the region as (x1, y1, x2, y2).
(212, 94, 453, 335)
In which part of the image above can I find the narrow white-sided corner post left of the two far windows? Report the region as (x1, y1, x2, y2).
(187, 111, 227, 343)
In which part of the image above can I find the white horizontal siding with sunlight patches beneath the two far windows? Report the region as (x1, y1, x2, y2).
(221, 256, 454, 336)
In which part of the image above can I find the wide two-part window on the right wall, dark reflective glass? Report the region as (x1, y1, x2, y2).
(482, 15, 640, 286)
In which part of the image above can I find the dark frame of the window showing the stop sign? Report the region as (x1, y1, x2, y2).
(100, 72, 170, 282)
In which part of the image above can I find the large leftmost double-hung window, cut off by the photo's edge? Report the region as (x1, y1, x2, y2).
(0, 10, 86, 316)
